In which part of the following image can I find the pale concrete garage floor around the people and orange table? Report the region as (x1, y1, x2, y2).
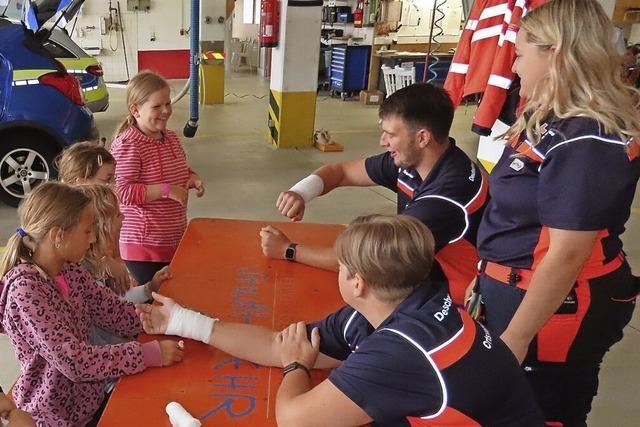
(0, 74, 640, 427)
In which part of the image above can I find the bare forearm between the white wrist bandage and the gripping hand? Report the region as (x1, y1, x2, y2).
(209, 321, 282, 366)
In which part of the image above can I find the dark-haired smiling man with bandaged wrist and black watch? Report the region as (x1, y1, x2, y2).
(260, 84, 488, 305)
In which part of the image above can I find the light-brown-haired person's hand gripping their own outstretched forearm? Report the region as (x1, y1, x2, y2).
(279, 322, 320, 369)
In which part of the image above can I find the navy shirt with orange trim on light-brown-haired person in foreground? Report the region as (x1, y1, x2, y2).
(307, 282, 543, 426)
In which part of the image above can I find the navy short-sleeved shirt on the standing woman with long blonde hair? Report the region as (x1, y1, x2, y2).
(478, 117, 640, 269)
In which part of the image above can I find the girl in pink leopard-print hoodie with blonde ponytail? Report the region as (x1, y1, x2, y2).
(0, 182, 182, 427)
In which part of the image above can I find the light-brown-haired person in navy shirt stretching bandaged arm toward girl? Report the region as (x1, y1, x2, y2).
(138, 215, 544, 427)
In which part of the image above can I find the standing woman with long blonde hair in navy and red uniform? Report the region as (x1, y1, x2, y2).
(478, 0, 640, 426)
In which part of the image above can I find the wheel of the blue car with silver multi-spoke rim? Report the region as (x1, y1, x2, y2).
(0, 131, 59, 207)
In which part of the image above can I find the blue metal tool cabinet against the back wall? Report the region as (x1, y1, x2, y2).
(331, 45, 371, 99)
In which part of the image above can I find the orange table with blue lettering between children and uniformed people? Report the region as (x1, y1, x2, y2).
(99, 219, 344, 427)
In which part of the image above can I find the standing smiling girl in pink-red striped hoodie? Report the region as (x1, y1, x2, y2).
(111, 71, 204, 283)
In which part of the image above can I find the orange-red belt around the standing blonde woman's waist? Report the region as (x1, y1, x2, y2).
(479, 252, 625, 290)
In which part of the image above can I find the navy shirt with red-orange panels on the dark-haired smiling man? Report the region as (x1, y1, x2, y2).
(365, 138, 488, 305)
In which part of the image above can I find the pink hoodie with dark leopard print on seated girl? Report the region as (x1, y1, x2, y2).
(0, 263, 161, 427)
